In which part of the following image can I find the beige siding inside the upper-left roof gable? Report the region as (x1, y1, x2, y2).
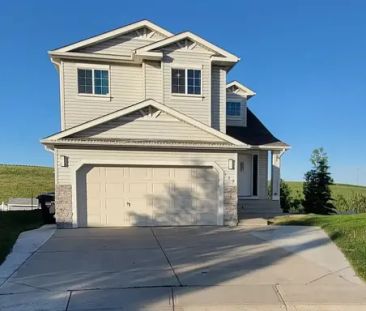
(76, 32, 165, 55)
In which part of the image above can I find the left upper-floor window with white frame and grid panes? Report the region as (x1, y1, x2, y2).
(78, 68, 109, 95)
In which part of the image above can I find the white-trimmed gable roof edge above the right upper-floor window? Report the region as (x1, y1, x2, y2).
(135, 31, 240, 63)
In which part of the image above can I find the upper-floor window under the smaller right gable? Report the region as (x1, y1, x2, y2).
(172, 68, 201, 95)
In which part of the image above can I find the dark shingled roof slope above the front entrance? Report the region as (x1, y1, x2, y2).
(226, 108, 290, 149)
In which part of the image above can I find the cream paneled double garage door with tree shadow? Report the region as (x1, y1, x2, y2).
(84, 166, 218, 226)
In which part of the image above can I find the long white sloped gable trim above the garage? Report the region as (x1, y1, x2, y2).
(41, 99, 250, 148)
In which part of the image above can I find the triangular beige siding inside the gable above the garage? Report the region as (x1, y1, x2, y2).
(73, 113, 226, 142)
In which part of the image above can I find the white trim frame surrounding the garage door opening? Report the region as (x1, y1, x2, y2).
(72, 159, 224, 228)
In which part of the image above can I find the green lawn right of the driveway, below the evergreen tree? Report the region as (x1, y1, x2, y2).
(273, 214, 366, 280)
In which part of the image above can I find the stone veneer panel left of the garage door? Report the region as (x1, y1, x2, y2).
(55, 185, 72, 228)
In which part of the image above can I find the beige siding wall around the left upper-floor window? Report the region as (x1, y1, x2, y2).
(63, 61, 144, 129)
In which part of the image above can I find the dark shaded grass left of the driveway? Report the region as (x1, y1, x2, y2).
(0, 210, 43, 264)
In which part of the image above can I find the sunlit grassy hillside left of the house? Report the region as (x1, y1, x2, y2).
(0, 164, 54, 204)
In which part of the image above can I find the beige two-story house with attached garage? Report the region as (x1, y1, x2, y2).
(41, 20, 289, 227)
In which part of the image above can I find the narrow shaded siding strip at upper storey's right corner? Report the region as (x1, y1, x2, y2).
(211, 66, 226, 133)
